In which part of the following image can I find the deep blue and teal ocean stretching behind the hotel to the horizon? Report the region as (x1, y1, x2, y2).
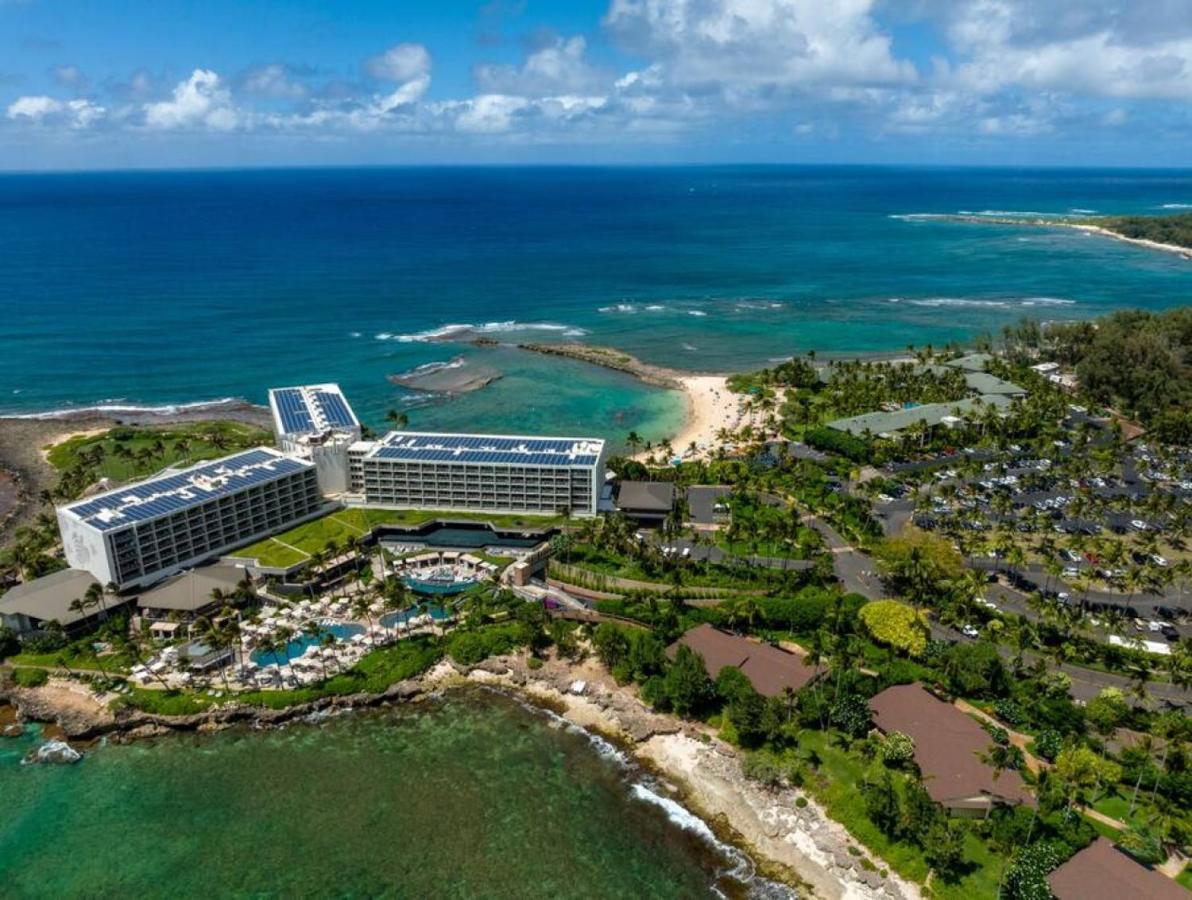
(0, 167, 1192, 448)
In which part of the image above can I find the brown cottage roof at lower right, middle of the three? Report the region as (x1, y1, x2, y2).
(869, 684, 1033, 803)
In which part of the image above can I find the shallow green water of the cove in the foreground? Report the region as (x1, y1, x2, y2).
(0, 693, 762, 900)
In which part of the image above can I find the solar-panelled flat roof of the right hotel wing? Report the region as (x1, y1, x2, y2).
(367, 432, 604, 467)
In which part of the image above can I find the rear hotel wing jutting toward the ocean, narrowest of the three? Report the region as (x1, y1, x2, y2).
(269, 384, 362, 494)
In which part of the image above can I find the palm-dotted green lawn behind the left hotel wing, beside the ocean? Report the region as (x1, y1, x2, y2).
(48, 422, 273, 482)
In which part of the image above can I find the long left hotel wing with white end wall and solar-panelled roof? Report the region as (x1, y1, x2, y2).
(58, 447, 325, 590)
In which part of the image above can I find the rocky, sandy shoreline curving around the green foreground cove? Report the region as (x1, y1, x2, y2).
(0, 653, 920, 900)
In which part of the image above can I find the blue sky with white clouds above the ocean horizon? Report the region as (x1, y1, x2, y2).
(0, 0, 1192, 170)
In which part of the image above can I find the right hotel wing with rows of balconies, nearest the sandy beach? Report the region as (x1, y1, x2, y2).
(349, 432, 604, 516)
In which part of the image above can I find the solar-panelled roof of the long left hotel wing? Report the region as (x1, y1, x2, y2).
(58, 447, 313, 532)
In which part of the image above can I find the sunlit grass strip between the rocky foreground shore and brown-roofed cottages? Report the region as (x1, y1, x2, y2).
(799, 731, 1001, 900)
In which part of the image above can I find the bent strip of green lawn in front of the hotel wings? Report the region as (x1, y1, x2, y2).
(232, 507, 564, 569)
